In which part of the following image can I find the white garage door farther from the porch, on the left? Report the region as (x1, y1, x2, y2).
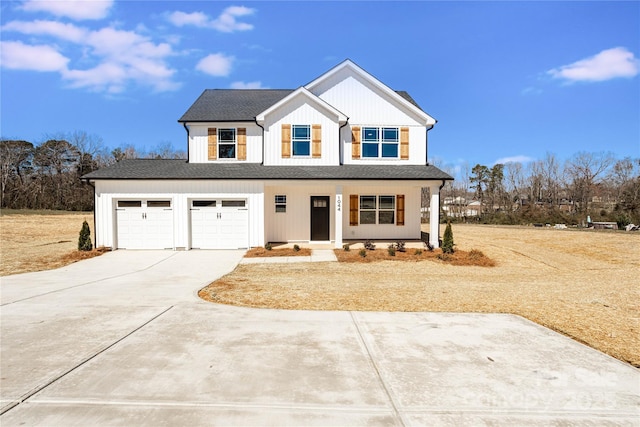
(116, 200, 173, 249)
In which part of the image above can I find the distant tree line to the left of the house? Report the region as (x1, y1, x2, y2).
(0, 131, 186, 211)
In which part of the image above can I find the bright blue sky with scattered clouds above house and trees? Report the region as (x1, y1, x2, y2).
(0, 0, 640, 174)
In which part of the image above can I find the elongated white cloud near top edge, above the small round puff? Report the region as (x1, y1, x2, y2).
(168, 6, 255, 33)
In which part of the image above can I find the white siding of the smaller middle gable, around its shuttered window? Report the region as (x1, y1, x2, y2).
(264, 96, 340, 166)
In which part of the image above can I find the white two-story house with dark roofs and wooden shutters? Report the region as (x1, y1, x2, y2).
(84, 60, 452, 249)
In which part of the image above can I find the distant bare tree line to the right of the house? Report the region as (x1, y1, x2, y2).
(426, 152, 640, 226)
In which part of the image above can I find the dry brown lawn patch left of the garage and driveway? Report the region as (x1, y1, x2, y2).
(0, 212, 100, 276)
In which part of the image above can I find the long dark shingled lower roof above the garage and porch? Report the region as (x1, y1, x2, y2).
(82, 159, 453, 181)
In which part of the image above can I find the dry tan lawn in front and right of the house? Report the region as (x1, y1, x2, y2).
(200, 225, 640, 366)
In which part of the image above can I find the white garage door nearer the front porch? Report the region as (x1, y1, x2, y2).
(191, 199, 249, 249)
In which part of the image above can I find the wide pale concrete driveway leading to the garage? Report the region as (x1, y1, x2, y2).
(0, 251, 640, 427)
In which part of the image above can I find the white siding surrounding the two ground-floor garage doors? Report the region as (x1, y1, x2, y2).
(95, 180, 264, 249)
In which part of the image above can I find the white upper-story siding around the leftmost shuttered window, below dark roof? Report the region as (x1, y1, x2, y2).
(188, 122, 262, 163)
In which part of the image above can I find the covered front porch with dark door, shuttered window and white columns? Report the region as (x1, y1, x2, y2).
(264, 180, 442, 248)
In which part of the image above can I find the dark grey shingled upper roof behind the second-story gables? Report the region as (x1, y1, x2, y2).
(178, 89, 420, 123)
